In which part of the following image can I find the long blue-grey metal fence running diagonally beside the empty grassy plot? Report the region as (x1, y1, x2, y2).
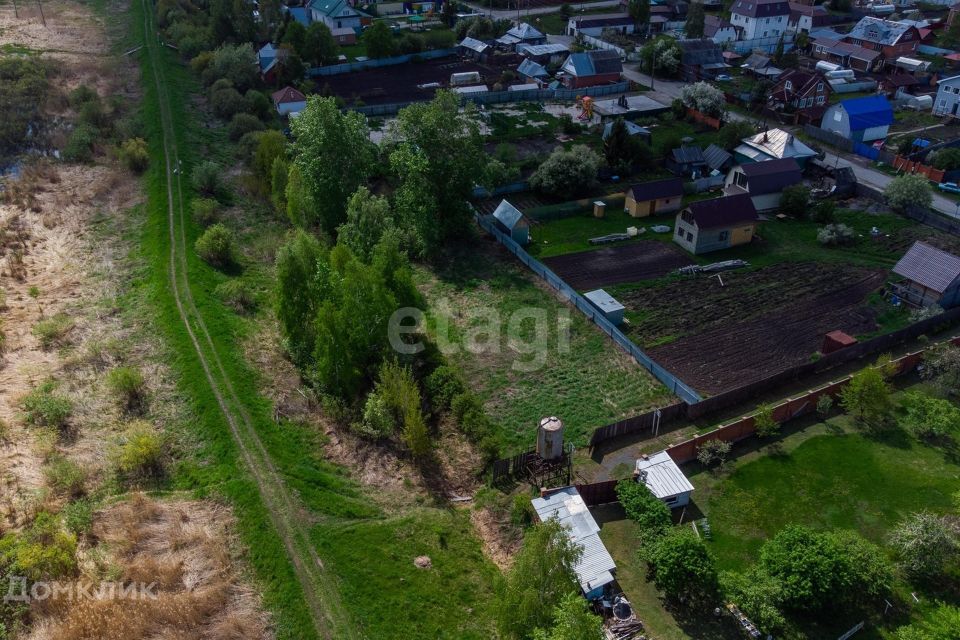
(477, 215, 701, 403)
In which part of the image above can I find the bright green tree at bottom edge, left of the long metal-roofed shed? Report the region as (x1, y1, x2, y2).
(497, 519, 583, 640)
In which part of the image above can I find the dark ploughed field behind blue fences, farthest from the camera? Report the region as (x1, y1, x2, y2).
(314, 57, 500, 105)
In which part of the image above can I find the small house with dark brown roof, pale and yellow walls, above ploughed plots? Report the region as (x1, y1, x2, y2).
(673, 193, 760, 254)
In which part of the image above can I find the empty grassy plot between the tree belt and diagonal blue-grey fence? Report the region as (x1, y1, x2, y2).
(417, 244, 672, 451)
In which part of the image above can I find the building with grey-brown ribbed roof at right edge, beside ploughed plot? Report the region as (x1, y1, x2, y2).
(892, 241, 960, 309)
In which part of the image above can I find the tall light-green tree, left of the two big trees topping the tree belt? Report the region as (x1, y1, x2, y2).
(291, 96, 376, 234)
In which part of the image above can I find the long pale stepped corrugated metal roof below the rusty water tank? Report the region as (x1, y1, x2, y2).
(530, 487, 617, 593)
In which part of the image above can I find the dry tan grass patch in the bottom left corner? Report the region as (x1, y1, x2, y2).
(27, 494, 272, 640)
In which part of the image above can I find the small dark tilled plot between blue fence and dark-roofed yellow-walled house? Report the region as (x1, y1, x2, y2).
(543, 241, 693, 291)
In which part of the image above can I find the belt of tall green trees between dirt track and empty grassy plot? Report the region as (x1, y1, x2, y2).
(270, 92, 498, 460)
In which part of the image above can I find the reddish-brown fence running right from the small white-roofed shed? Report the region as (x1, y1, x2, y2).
(667, 338, 960, 464)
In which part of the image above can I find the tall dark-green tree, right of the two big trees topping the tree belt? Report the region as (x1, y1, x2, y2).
(390, 91, 486, 255)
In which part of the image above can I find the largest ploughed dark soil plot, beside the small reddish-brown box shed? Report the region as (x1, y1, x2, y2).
(619, 263, 886, 393)
